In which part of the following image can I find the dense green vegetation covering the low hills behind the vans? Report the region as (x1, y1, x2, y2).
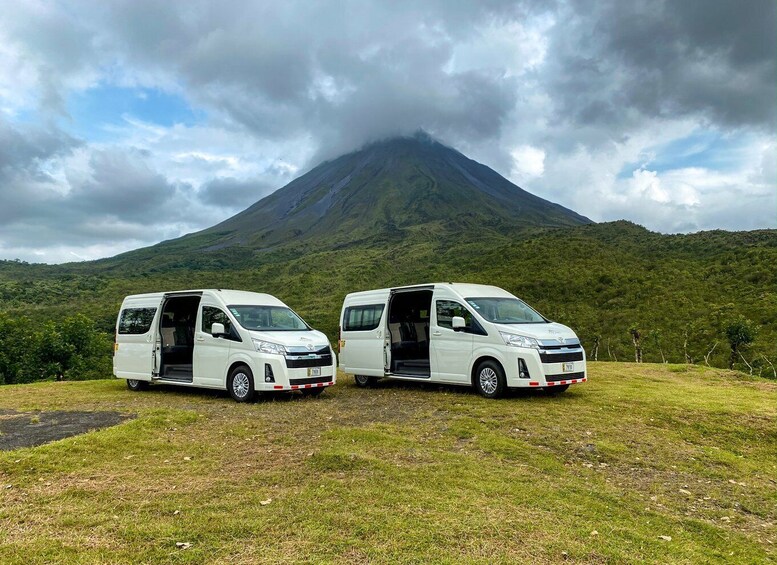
(0, 222, 777, 384)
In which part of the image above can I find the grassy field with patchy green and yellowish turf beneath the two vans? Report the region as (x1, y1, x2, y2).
(0, 363, 777, 564)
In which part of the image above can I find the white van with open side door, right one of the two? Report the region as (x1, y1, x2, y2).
(340, 283, 587, 398)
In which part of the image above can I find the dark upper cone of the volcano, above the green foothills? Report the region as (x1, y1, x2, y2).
(184, 134, 590, 250)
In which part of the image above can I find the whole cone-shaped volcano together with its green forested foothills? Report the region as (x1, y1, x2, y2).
(0, 135, 777, 377)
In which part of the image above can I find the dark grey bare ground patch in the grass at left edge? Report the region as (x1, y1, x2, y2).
(0, 410, 135, 451)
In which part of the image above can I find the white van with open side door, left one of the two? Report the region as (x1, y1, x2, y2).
(113, 289, 337, 402)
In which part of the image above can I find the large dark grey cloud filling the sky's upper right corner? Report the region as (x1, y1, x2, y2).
(543, 0, 777, 137)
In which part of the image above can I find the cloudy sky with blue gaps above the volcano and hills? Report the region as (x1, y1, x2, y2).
(0, 0, 777, 263)
